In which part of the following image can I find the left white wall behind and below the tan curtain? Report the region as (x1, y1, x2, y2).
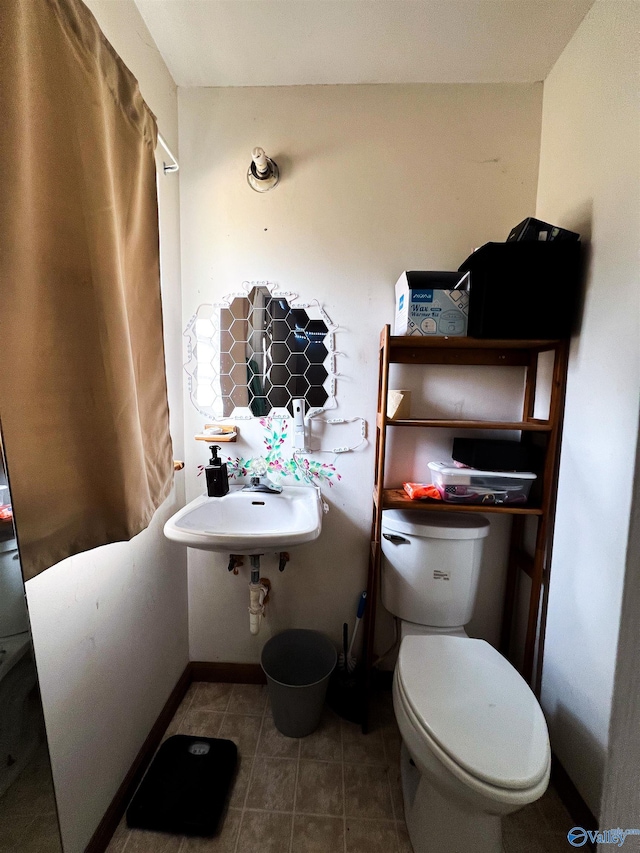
(27, 0, 188, 853)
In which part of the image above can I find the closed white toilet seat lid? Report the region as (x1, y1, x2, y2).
(396, 635, 551, 799)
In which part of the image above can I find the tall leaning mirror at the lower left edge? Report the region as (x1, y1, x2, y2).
(0, 441, 62, 853)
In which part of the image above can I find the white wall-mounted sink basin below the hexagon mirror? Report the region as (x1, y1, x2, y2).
(164, 485, 322, 555)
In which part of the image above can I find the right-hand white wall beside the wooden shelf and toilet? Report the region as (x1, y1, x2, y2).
(537, 0, 640, 825)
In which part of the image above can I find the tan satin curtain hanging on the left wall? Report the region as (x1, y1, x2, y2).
(0, 0, 173, 578)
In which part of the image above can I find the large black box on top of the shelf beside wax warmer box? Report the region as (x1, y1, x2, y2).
(459, 240, 581, 340)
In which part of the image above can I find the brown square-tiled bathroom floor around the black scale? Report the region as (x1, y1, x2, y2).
(107, 682, 573, 853)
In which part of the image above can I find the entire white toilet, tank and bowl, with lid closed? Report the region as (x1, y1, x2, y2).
(382, 510, 551, 853)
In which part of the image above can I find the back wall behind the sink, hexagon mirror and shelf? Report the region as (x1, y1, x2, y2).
(179, 84, 542, 661)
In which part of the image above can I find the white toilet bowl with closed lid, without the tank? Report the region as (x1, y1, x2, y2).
(393, 634, 551, 853)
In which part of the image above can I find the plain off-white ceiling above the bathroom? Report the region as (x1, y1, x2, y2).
(135, 0, 594, 86)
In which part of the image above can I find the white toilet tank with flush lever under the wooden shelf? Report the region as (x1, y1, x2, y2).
(382, 509, 489, 628)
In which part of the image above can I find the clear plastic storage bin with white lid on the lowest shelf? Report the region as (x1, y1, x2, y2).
(429, 462, 536, 504)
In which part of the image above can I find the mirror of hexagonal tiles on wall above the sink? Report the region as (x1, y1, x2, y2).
(185, 283, 335, 418)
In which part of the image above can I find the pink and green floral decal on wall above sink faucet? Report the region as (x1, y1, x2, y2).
(227, 417, 342, 486)
